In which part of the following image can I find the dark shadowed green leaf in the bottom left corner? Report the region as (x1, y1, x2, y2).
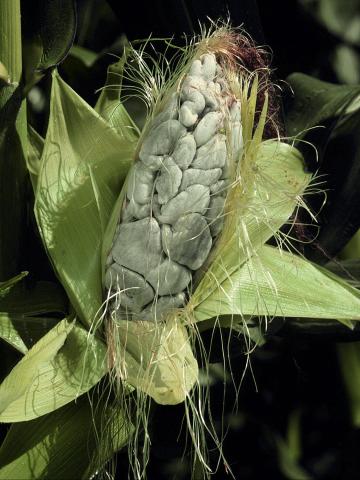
(0, 396, 131, 480)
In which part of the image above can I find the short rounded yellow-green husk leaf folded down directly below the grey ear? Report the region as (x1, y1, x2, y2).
(115, 318, 198, 405)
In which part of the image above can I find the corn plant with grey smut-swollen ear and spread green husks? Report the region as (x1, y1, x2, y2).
(0, 0, 360, 479)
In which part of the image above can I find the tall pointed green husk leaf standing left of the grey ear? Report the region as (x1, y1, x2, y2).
(35, 72, 135, 325)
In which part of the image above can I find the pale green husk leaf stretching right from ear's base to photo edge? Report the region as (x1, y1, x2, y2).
(195, 245, 360, 323)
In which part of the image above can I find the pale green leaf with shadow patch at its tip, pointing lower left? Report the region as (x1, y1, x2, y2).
(0, 319, 106, 422)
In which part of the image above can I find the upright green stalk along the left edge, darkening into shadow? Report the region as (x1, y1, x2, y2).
(0, 0, 27, 280)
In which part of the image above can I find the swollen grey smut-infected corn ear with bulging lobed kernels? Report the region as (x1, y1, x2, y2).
(105, 53, 242, 320)
